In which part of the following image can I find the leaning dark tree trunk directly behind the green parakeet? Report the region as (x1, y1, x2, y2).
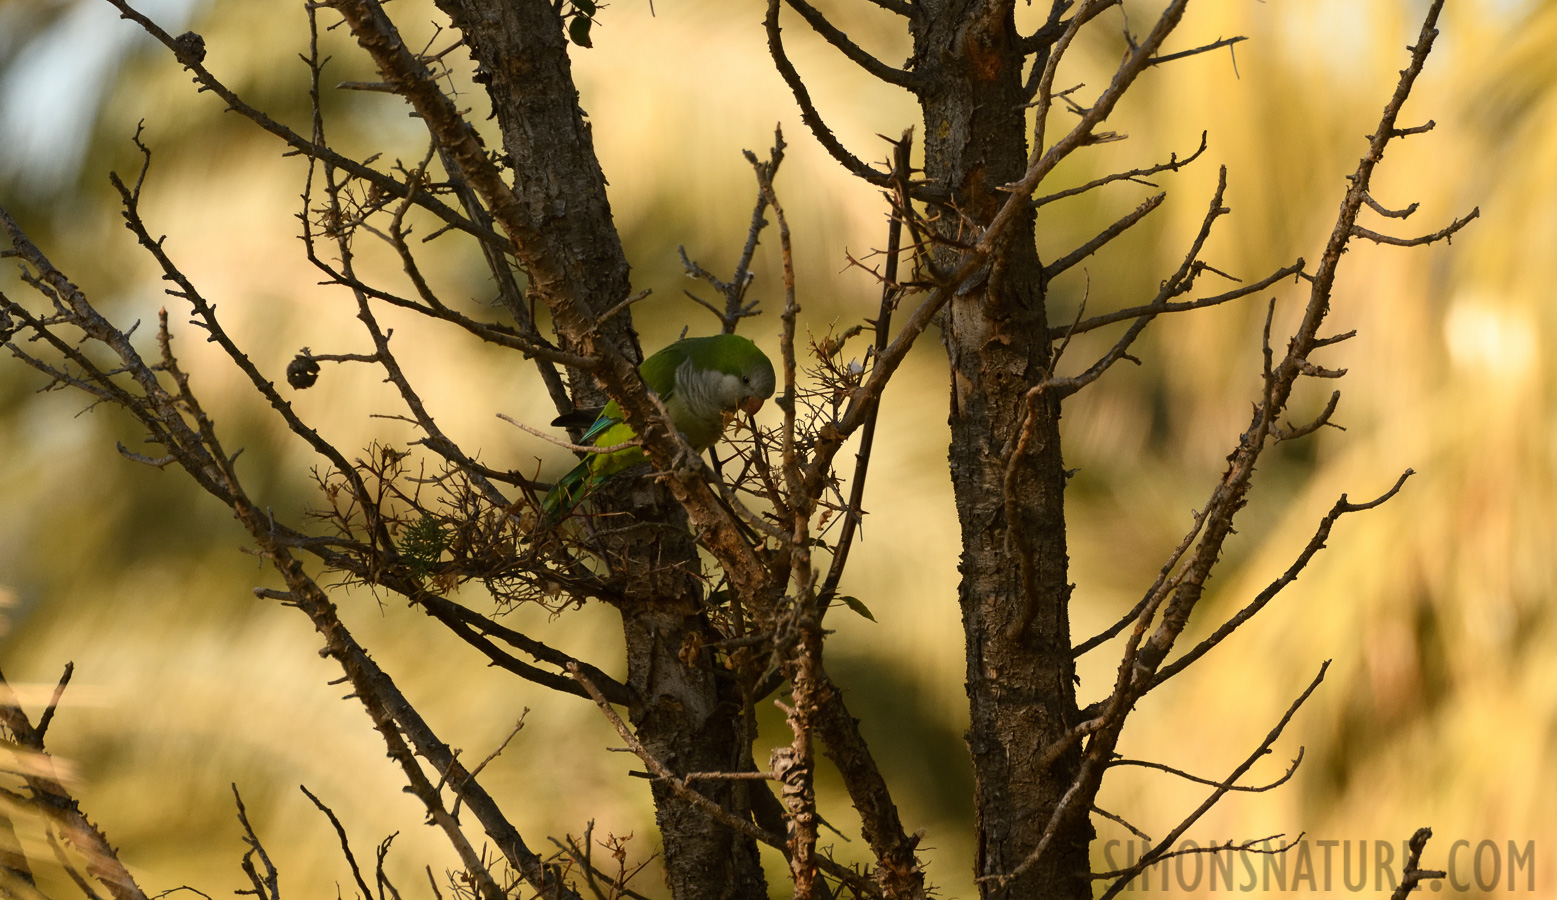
(439, 0, 768, 900)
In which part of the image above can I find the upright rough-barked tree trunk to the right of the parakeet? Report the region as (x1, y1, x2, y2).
(914, 0, 1093, 898)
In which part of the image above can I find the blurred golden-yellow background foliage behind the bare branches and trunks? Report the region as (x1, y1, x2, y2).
(0, 0, 1557, 897)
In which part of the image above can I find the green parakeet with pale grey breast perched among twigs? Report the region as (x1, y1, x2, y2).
(540, 335, 774, 522)
